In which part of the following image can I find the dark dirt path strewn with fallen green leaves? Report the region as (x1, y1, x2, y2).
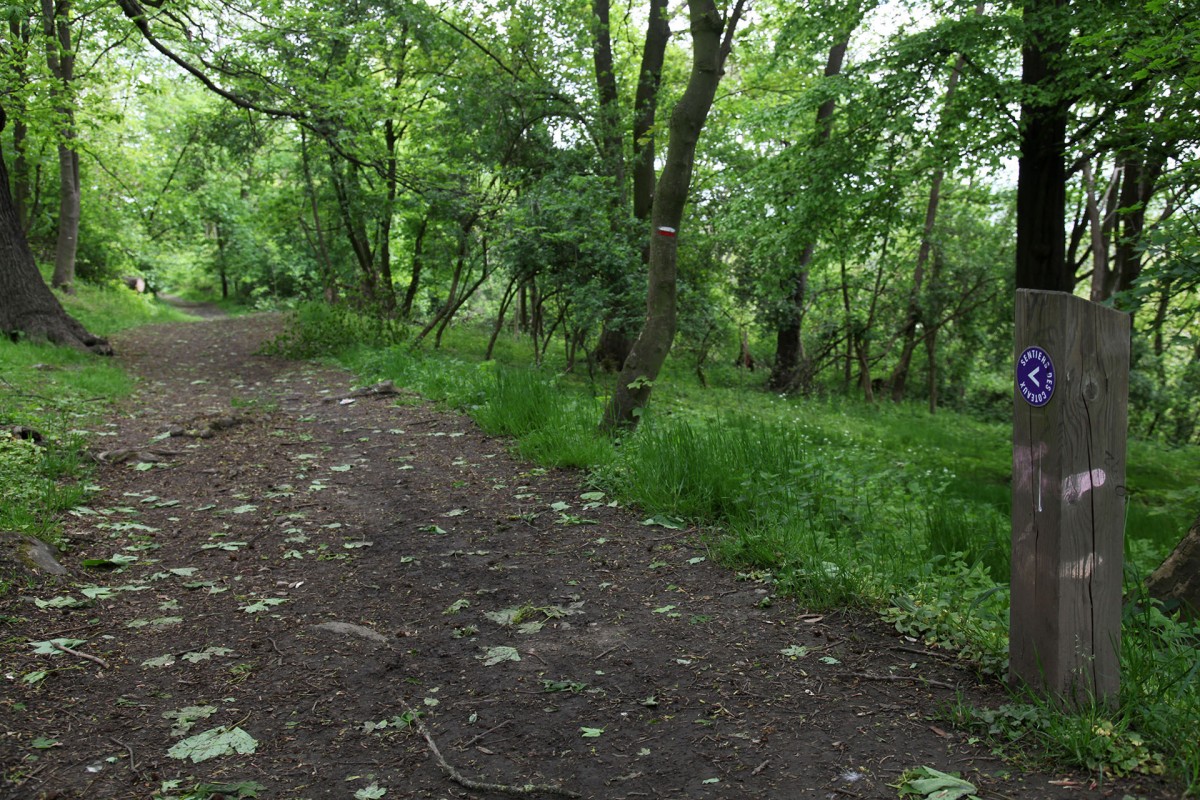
(0, 317, 1171, 800)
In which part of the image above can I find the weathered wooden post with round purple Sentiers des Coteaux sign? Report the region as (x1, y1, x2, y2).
(1009, 289, 1129, 705)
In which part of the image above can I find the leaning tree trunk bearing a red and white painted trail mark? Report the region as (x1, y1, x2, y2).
(601, 0, 743, 432)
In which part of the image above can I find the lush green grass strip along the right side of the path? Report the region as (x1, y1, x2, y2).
(267, 303, 1200, 795)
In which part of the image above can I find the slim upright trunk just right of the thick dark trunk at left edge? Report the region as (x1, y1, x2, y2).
(42, 0, 80, 294)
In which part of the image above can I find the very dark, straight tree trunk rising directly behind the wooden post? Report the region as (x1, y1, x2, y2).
(1016, 0, 1075, 291)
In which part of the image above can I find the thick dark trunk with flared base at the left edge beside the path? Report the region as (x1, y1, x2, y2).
(0, 106, 113, 355)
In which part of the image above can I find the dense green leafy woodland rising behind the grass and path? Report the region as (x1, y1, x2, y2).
(0, 0, 1200, 443)
